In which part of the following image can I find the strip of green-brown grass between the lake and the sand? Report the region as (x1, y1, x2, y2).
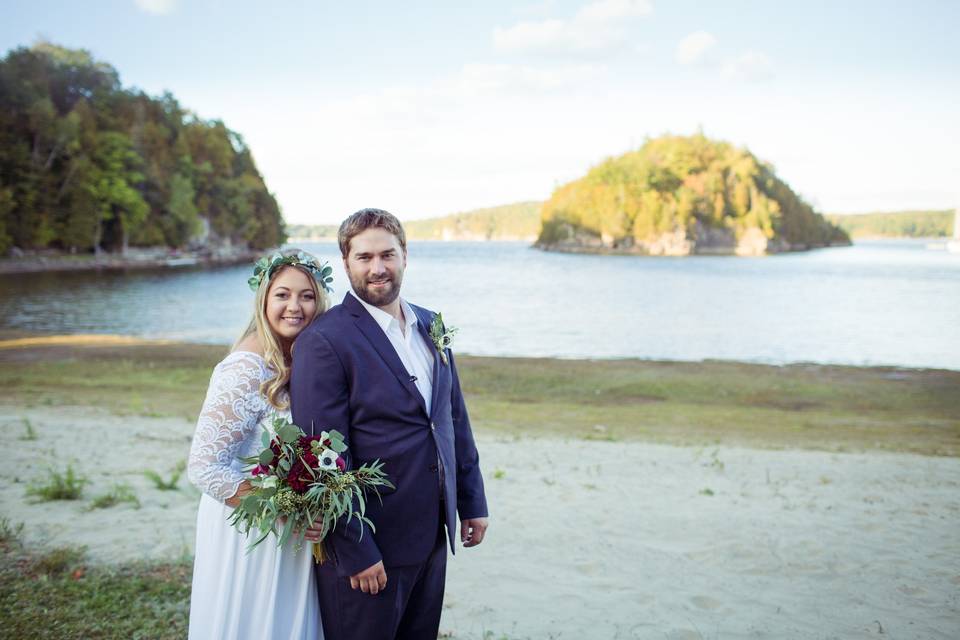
(0, 343, 960, 456)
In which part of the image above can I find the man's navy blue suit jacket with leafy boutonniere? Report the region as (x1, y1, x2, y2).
(290, 293, 487, 576)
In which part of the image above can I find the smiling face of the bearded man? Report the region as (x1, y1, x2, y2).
(343, 227, 407, 307)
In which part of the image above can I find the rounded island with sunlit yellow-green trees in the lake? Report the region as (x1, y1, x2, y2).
(537, 134, 850, 255)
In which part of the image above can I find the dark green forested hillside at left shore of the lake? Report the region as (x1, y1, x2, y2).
(0, 43, 284, 254)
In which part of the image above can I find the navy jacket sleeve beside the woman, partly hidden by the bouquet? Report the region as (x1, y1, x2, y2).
(290, 330, 383, 577)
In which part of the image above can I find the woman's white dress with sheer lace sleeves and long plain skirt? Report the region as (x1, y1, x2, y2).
(187, 351, 323, 640)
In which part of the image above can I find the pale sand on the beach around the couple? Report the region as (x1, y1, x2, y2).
(0, 407, 960, 640)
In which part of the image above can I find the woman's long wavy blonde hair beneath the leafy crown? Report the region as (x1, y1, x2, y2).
(232, 249, 330, 409)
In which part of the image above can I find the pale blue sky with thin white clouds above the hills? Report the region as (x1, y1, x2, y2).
(0, 0, 960, 224)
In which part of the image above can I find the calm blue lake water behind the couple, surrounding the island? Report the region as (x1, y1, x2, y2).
(0, 241, 960, 369)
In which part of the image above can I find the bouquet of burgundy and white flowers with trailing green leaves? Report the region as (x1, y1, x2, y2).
(230, 417, 393, 563)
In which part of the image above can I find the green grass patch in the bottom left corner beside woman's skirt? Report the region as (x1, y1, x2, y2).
(0, 521, 191, 640)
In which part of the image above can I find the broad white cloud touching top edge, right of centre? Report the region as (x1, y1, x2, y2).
(493, 0, 653, 52)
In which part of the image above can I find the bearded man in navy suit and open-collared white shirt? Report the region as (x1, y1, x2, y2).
(290, 209, 487, 640)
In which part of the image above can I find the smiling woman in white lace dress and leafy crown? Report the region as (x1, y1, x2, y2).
(187, 249, 330, 640)
